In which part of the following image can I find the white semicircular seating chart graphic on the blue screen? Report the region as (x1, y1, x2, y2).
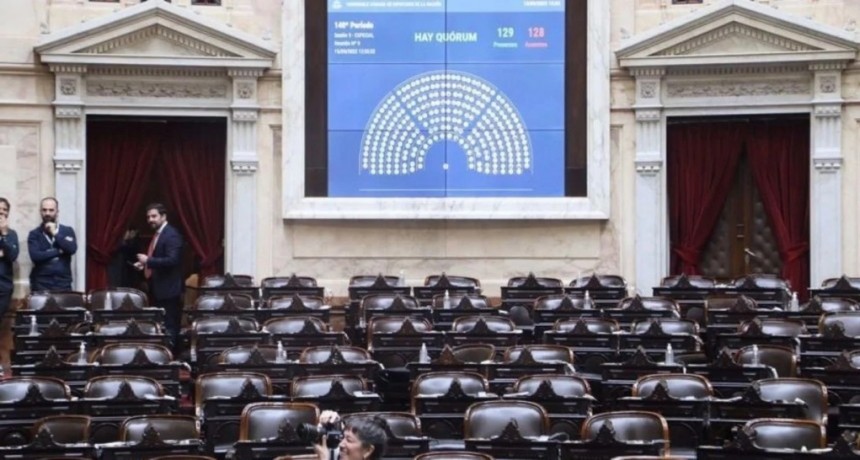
(361, 72, 531, 175)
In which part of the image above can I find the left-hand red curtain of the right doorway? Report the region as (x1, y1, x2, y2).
(664, 121, 745, 275)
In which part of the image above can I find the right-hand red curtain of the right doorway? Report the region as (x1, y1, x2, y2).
(747, 120, 810, 299)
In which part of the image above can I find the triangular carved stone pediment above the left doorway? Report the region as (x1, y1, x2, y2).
(36, 0, 277, 69)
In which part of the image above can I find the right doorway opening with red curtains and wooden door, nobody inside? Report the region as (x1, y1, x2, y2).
(667, 114, 810, 292)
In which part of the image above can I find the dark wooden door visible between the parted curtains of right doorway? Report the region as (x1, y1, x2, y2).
(699, 155, 782, 281)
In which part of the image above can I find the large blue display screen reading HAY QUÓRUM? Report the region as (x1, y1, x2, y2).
(327, 0, 565, 197)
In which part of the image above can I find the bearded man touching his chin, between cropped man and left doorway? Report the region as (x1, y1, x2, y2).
(27, 197, 78, 292)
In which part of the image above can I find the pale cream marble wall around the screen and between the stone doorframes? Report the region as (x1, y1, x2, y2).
(0, 0, 860, 295)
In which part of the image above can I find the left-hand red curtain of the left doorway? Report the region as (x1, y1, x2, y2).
(87, 121, 163, 290)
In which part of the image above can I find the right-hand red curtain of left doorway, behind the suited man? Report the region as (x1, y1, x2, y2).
(160, 122, 223, 276)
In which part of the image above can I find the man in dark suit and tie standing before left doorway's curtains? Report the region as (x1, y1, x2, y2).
(135, 203, 182, 345)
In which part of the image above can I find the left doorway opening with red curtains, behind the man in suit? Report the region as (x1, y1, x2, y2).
(86, 116, 227, 291)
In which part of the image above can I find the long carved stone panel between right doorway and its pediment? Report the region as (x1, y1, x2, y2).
(666, 80, 811, 99)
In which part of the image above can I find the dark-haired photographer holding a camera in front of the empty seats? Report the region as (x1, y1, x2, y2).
(314, 411, 388, 460)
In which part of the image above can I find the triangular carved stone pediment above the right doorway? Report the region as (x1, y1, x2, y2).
(616, 0, 857, 68)
